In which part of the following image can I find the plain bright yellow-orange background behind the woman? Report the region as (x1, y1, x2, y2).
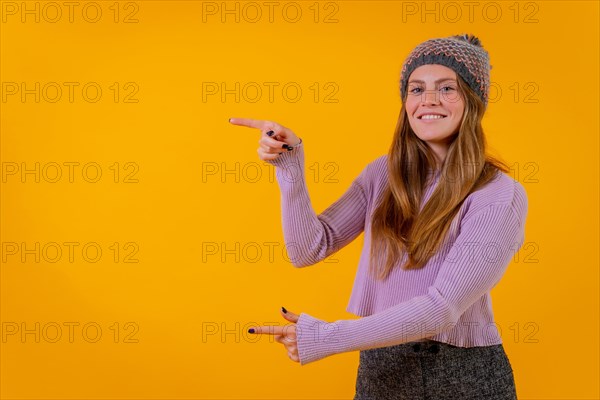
(0, 1, 599, 399)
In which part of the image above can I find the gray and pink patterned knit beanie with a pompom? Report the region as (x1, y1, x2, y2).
(400, 34, 492, 107)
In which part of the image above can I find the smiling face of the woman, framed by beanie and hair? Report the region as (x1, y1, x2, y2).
(406, 64, 465, 161)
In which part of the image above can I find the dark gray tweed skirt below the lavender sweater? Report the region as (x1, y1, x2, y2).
(354, 340, 517, 400)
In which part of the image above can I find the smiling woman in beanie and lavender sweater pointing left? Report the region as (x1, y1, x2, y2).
(230, 35, 527, 400)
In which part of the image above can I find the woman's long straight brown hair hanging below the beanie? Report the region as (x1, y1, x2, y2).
(370, 74, 509, 279)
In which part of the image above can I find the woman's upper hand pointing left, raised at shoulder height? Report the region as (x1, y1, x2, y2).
(229, 118, 302, 161)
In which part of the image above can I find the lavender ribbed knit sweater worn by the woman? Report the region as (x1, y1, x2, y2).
(269, 142, 528, 365)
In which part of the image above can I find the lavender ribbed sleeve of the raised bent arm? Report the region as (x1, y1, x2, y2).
(269, 139, 367, 267)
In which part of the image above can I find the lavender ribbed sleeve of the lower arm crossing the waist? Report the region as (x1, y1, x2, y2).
(296, 204, 524, 365)
